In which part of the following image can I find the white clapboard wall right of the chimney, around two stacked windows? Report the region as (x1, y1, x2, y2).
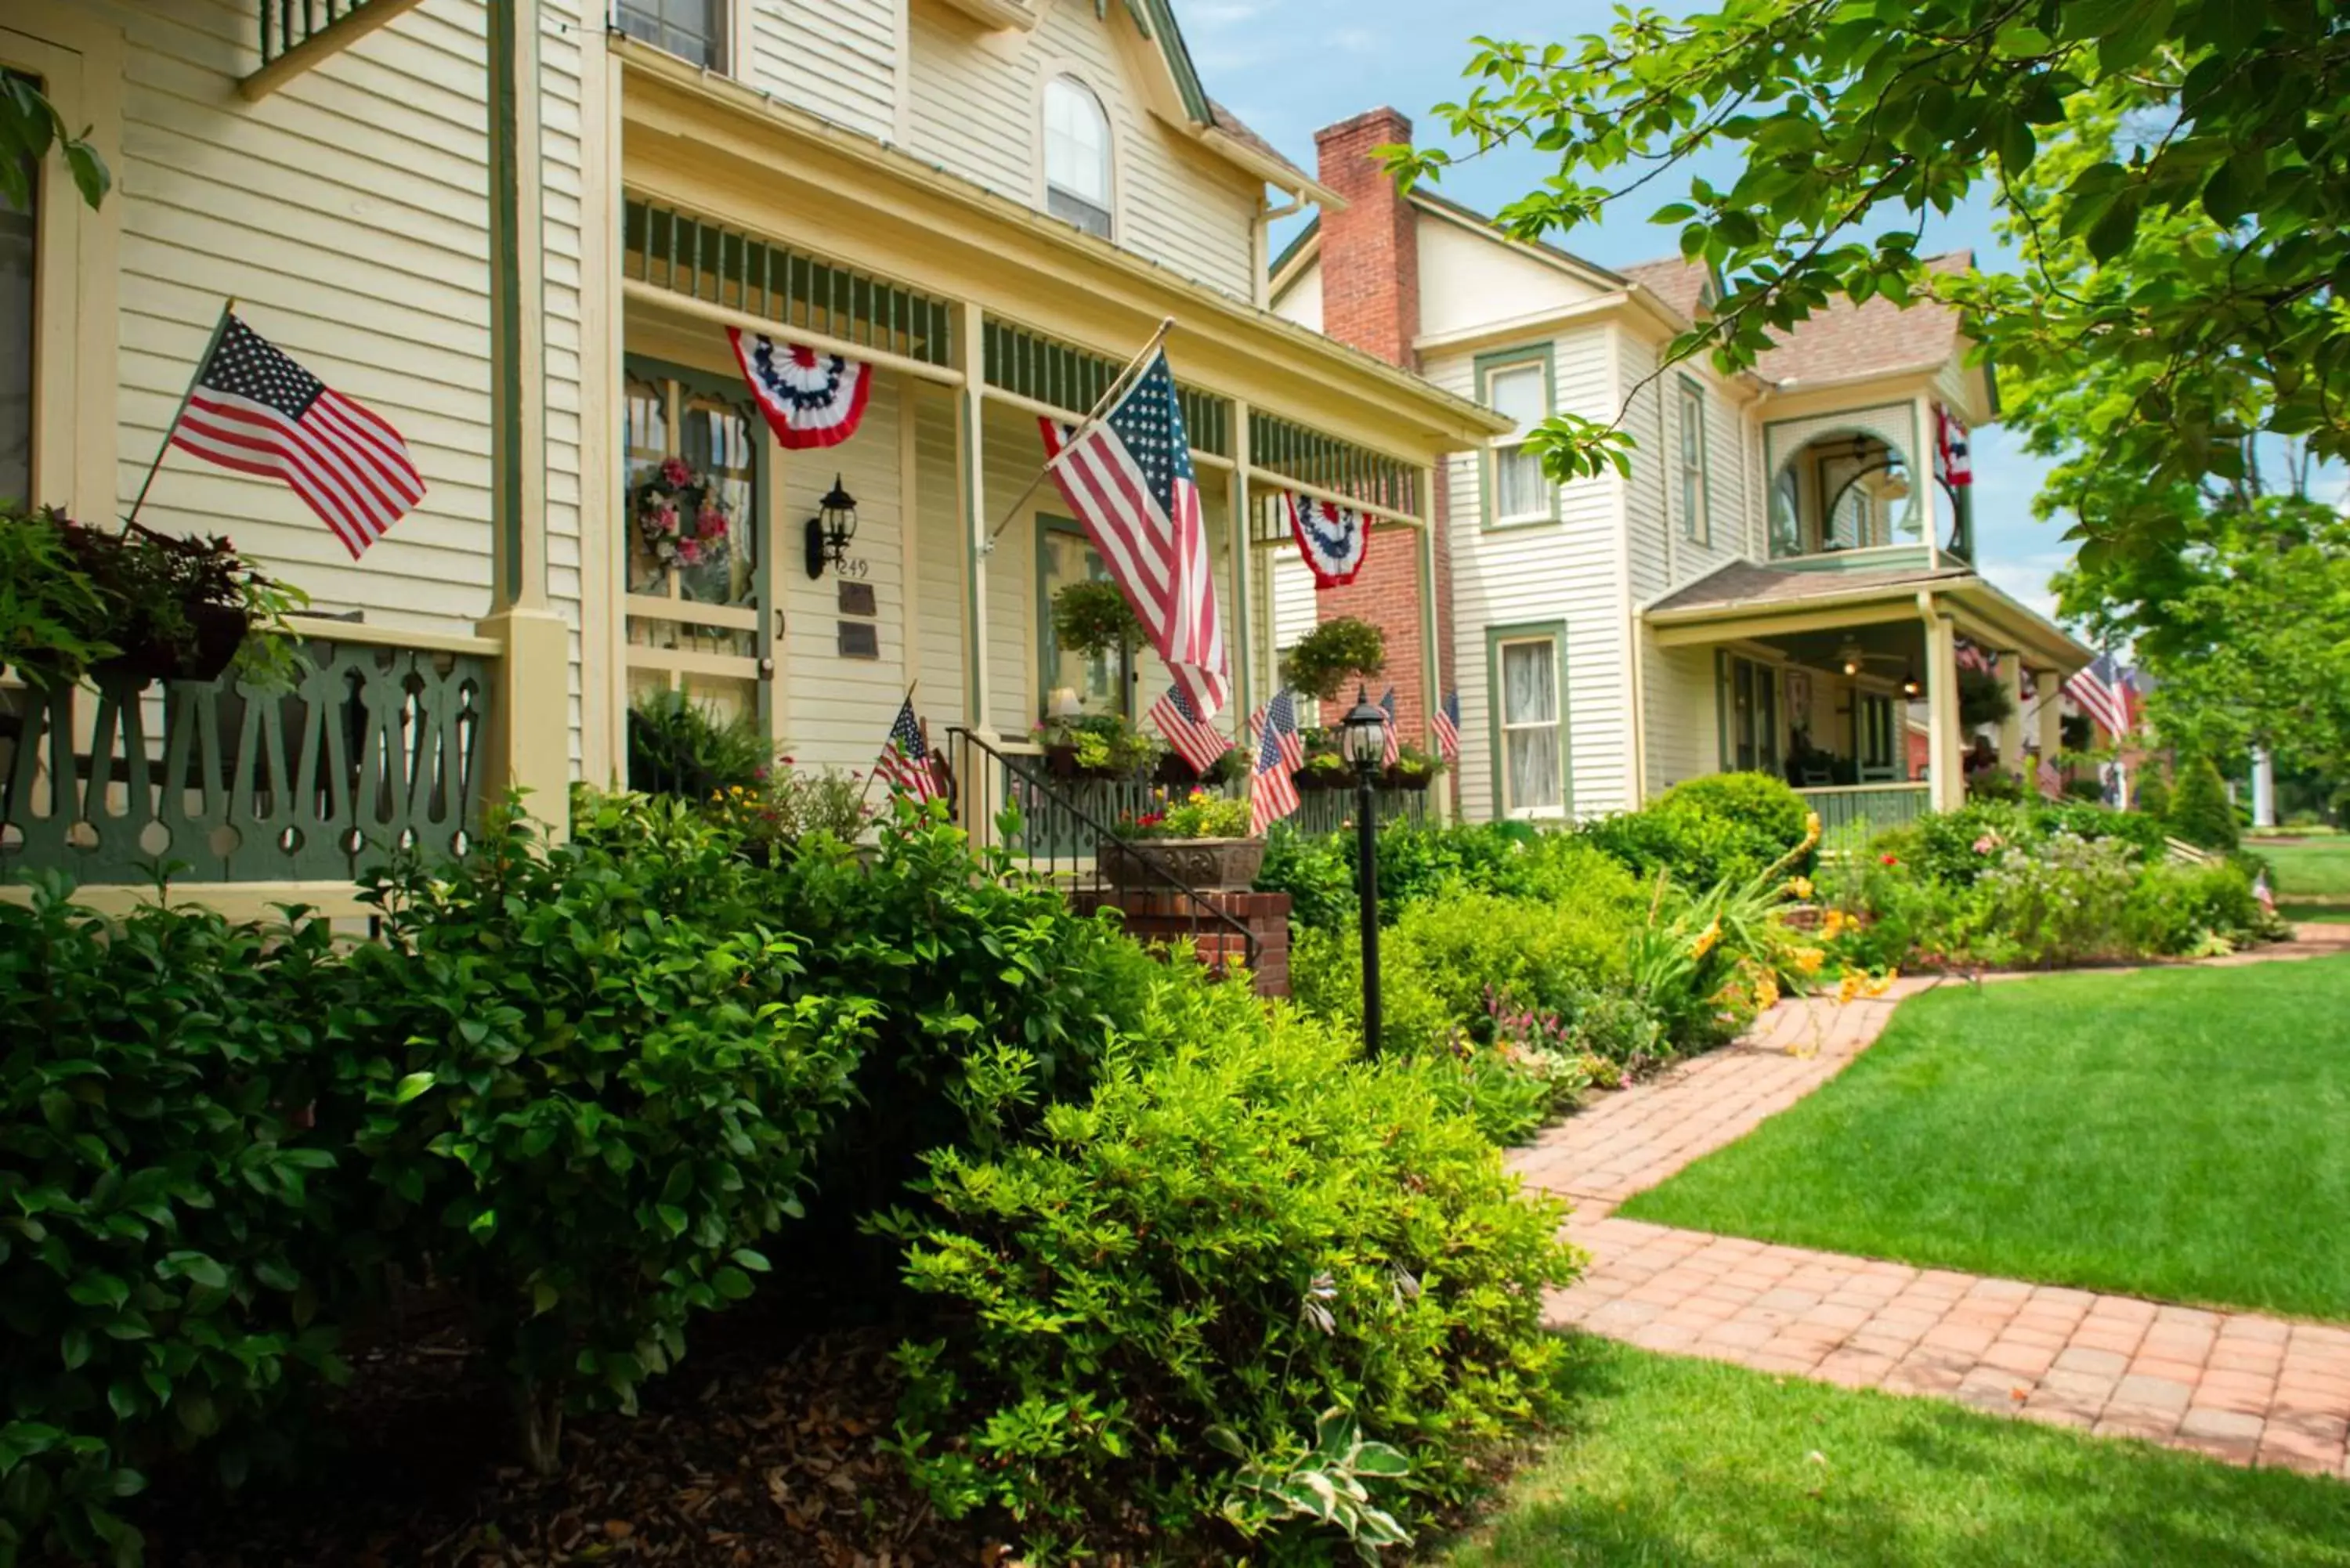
(1426, 324, 1631, 821)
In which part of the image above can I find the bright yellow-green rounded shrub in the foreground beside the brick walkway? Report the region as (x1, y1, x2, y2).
(886, 988, 1577, 1561)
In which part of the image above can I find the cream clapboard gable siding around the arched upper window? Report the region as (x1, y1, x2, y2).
(907, 0, 1262, 298)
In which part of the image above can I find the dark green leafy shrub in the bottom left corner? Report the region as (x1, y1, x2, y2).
(0, 882, 338, 1563)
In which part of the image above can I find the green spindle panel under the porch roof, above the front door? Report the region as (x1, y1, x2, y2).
(620, 197, 954, 364)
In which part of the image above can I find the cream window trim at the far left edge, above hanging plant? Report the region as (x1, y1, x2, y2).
(0, 0, 120, 522)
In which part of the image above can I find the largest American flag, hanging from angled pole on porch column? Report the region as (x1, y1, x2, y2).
(1039, 350, 1229, 719)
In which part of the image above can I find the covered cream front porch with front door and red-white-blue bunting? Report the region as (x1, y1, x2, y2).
(611, 45, 1506, 849)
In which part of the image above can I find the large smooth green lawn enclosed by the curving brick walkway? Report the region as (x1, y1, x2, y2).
(1624, 959, 2350, 1319)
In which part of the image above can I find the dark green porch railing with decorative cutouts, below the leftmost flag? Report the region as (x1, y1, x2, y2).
(0, 639, 494, 884)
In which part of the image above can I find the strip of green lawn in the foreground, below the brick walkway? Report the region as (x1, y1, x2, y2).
(1436, 1340, 2350, 1568)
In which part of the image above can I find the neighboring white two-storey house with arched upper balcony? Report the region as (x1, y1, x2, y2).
(1274, 110, 2089, 841)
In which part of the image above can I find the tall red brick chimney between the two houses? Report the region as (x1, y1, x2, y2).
(1314, 108, 1452, 761)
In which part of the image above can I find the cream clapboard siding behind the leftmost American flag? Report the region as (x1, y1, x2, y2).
(94, 0, 592, 759)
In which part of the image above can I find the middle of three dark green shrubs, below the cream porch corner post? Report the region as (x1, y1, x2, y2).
(350, 802, 874, 1472)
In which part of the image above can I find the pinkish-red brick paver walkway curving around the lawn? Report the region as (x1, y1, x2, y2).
(1511, 927, 2350, 1479)
